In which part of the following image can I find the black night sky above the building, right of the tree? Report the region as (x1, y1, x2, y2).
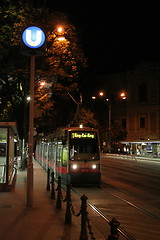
(46, 0, 160, 73)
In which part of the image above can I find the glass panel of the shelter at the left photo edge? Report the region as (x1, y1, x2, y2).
(0, 128, 8, 183)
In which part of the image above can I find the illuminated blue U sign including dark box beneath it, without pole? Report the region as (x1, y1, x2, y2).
(22, 26, 46, 56)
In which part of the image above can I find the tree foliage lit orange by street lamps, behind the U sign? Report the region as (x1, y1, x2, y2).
(0, 0, 86, 138)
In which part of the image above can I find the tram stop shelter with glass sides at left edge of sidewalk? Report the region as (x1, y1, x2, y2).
(0, 122, 18, 192)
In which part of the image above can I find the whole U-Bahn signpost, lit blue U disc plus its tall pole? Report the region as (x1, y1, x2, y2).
(22, 26, 46, 208)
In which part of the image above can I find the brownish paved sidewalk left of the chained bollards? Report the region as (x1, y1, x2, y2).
(0, 161, 80, 240)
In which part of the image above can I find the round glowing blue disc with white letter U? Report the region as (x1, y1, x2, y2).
(22, 26, 45, 49)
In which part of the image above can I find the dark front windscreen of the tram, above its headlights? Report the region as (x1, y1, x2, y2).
(70, 133, 99, 161)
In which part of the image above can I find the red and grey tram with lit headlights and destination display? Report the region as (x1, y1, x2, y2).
(35, 127, 101, 186)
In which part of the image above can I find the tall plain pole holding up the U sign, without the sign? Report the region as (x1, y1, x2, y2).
(27, 56, 35, 207)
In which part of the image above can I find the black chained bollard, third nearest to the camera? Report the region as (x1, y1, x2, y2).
(65, 184, 72, 225)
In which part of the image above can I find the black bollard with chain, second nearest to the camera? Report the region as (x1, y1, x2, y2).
(79, 195, 88, 240)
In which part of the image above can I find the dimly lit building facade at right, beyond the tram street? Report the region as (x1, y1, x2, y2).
(94, 63, 160, 156)
